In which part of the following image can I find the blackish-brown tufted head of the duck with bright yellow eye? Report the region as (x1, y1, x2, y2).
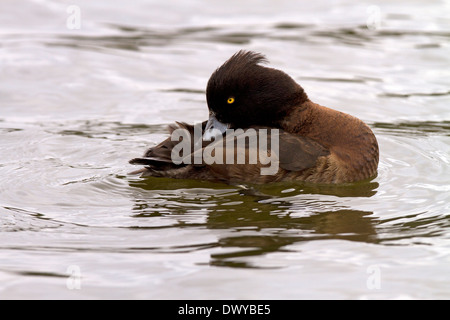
(206, 51, 307, 128)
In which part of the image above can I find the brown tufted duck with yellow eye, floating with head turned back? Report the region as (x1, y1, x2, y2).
(129, 50, 379, 185)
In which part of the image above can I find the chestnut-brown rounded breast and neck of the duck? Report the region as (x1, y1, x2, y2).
(284, 101, 379, 184)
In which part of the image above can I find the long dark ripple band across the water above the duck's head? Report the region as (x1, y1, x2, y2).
(34, 23, 450, 54)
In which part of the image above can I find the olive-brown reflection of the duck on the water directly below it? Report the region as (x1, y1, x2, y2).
(126, 178, 378, 268)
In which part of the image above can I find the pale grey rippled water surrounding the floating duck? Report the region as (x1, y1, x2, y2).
(0, 0, 450, 299)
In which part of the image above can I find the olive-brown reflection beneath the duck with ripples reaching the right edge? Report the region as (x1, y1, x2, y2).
(129, 165, 450, 269)
